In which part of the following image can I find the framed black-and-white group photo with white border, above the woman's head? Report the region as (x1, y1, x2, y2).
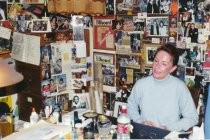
(146, 16, 169, 37)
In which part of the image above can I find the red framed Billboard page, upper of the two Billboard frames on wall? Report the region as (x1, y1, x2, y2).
(93, 17, 115, 50)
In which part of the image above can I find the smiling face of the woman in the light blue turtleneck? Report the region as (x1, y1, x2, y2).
(152, 51, 176, 80)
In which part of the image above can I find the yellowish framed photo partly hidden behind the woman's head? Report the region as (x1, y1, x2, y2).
(144, 44, 161, 66)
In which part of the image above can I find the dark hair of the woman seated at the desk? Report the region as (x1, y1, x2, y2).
(155, 44, 179, 66)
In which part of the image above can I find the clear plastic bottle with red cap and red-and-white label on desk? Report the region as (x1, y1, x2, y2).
(117, 105, 131, 140)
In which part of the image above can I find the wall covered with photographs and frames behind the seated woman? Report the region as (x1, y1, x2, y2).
(0, 0, 210, 119)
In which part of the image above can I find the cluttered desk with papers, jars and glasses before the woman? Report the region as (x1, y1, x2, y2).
(3, 109, 203, 140)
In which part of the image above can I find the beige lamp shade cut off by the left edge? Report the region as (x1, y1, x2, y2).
(0, 59, 23, 87)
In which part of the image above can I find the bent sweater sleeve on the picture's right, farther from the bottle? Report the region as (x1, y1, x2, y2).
(167, 86, 198, 131)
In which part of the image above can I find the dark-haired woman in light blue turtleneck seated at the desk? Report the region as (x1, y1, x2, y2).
(127, 44, 198, 131)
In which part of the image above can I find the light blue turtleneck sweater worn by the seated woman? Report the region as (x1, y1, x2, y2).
(127, 75, 198, 131)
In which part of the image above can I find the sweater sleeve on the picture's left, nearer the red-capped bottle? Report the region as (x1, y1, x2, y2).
(127, 81, 143, 123)
